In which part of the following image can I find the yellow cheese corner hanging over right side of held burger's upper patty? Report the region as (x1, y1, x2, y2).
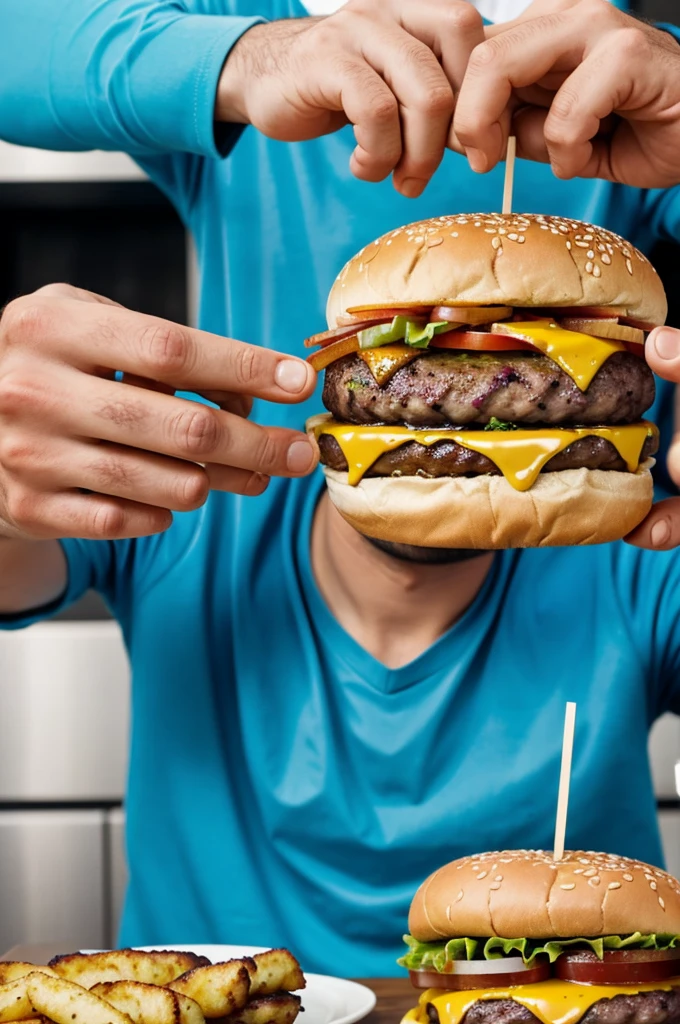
(492, 319, 626, 391)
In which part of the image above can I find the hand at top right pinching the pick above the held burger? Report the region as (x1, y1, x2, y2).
(454, 0, 680, 188)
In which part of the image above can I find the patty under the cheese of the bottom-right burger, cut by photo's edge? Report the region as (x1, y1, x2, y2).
(427, 989, 680, 1024)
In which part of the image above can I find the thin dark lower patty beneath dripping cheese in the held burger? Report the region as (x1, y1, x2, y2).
(318, 434, 659, 479)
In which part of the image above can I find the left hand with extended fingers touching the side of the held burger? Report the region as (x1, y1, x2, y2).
(0, 285, 316, 543)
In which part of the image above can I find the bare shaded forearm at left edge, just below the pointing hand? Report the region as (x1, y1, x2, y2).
(0, 537, 67, 615)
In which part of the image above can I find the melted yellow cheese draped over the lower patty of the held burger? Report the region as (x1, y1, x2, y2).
(313, 417, 658, 490)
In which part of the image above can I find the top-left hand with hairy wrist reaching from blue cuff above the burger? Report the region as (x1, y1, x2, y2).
(216, 0, 484, 197)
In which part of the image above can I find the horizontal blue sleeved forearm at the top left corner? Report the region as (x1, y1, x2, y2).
(0, 0, 261, 156)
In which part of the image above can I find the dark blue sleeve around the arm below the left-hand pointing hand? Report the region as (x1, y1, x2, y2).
(0, 540, 116, 630)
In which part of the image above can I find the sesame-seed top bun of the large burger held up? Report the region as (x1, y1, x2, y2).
(327, 213, 668, 328)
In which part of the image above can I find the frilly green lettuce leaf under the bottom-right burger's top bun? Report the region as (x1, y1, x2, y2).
(397, 932, 680, 974)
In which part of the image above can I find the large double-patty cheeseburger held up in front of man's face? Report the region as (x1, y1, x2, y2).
(307, 214, 667, 549)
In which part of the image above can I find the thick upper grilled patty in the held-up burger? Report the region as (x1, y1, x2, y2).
(323, 349, 654, 427)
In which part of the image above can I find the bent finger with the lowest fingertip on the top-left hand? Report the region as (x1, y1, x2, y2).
(363, 23, 454, 199)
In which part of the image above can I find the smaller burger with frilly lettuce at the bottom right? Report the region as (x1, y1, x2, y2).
(399, 850, 680, 1024)
